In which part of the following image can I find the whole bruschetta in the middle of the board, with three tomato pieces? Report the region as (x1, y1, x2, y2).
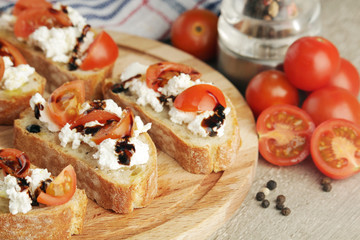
(14, 80, 157, 213)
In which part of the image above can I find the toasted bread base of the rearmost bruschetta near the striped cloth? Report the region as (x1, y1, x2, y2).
(0, 29, 114, 100)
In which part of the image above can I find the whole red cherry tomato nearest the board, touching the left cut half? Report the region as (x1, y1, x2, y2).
(245, 70, 299, 117)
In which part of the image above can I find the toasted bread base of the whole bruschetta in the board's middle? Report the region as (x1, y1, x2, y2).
(14, 109, 157, 213)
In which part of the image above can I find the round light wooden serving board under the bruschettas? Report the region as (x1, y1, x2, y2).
(0, 32, 258, 239)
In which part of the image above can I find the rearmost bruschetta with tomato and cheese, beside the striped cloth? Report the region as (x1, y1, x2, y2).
(0, 0, 118, 99)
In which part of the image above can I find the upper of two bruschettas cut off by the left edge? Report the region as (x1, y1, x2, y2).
(0, 39, 46, 125)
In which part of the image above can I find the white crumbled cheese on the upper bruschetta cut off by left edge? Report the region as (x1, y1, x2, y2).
(2, 57, 35, 91)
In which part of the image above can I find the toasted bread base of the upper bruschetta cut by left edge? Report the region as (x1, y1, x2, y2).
(0, 72, 46, 125)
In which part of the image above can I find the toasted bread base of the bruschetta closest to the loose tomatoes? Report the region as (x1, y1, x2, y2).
(103, 79, 241, 174)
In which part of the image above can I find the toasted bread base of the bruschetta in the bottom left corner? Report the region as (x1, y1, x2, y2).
(0, 166, 88, 240)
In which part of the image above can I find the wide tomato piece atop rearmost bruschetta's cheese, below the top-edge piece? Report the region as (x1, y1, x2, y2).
(14, 8, 72, 38)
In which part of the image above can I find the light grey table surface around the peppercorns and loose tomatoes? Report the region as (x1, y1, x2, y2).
(209, 0, 360, 240)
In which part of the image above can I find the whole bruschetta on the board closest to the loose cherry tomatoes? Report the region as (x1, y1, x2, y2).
(103, 62, 241, 174)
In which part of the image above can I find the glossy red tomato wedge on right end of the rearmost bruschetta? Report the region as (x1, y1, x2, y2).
(80, 31, 119, 70)
